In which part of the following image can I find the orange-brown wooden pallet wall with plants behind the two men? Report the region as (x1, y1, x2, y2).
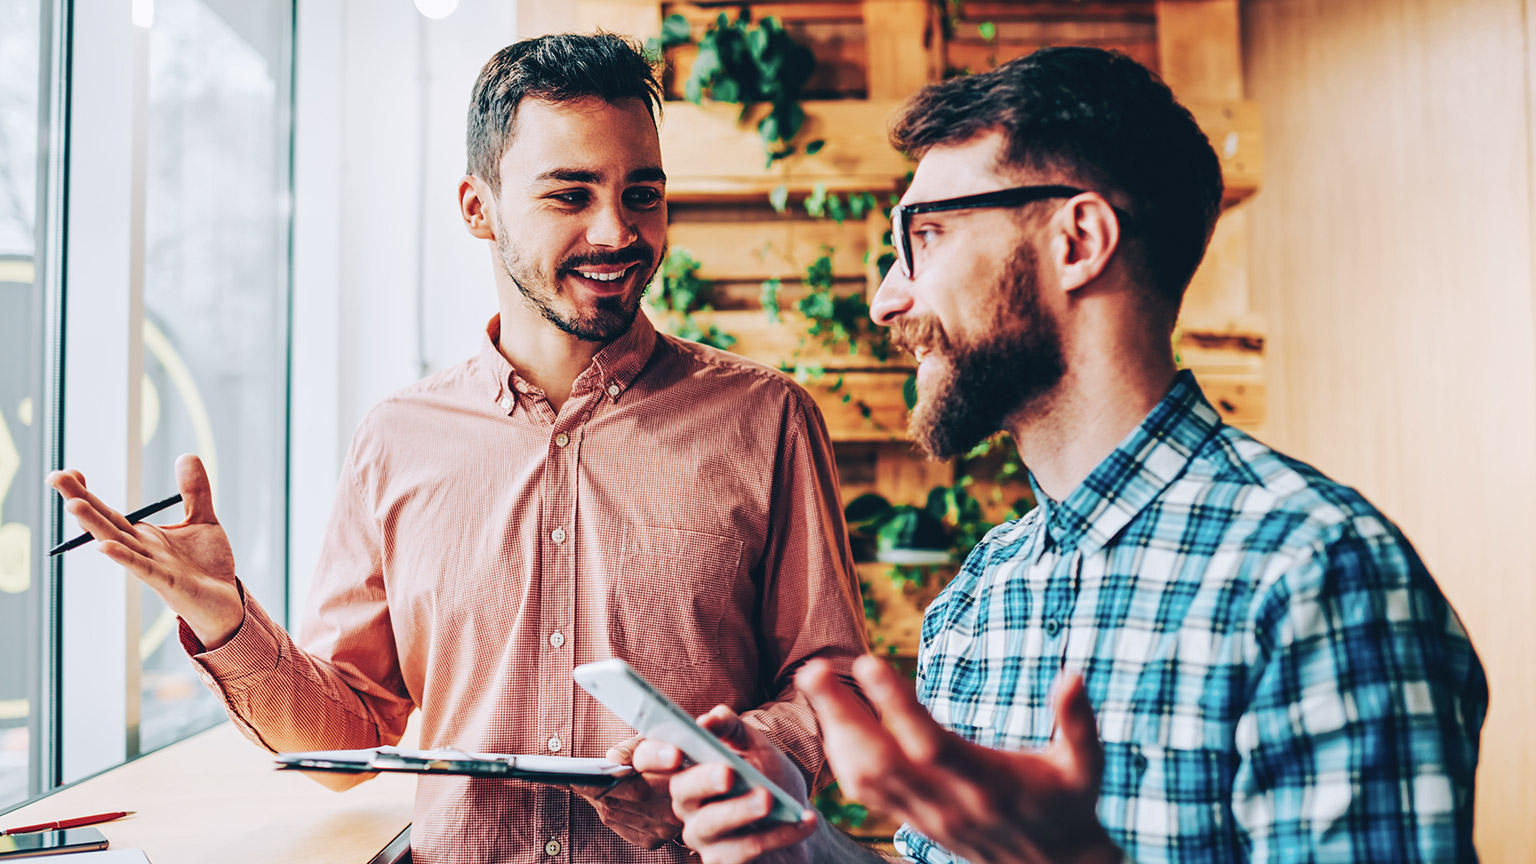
(519, 0, 1266, 836)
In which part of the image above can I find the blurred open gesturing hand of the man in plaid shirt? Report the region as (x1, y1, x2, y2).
(796, 655, 1120, 864)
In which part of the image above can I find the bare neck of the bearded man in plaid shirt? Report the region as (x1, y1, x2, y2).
(1008, 352, 1178, 501)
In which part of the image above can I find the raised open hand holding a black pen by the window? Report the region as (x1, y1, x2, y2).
(48, 455, 246, 650)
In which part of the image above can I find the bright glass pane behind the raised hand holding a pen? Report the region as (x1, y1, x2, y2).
(140, 0, 292, 750)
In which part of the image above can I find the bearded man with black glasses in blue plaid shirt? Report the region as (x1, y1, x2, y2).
(636, 48, 1488, 864)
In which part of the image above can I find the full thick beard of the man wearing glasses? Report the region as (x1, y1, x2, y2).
(891, 248, 1066, 460)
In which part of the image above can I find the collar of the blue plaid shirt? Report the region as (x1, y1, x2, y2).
(1029, 369, 1221, 555)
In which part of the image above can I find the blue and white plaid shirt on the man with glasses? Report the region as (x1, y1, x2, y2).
(895, 372, 1488, 864)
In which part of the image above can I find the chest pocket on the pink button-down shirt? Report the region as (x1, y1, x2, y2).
(610, 526, 743, 672)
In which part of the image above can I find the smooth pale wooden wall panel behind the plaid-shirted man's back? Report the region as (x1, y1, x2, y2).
(1243, 0, 1536, 861)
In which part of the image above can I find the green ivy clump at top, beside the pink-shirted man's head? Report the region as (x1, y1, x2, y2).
(660, 8, 826, 168)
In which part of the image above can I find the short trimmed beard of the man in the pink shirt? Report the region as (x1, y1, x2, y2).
(496, 237, 664, 343)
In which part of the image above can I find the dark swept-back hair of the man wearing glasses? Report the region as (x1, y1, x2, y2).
(891, 48, 1221, 309)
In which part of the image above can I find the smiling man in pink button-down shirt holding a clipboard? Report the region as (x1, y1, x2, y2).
(49, 35, 865, 864)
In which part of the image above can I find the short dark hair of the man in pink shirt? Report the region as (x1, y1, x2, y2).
(465, 32, 662, 194)
